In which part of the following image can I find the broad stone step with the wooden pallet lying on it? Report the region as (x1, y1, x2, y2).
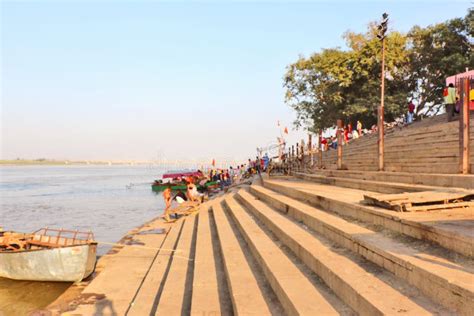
(264, 179, 474, 257)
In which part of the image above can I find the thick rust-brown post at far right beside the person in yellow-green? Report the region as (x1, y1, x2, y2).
(459, 78, 471, 174)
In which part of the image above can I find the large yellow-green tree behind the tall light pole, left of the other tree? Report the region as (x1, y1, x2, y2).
(284, 24, 408, 132)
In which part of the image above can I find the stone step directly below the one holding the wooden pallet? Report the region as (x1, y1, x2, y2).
(248, 186, 474, 314)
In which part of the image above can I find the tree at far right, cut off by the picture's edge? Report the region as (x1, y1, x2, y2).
(407, 9, 474, 115)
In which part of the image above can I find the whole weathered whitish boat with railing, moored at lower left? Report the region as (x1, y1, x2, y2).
(0, 228, 97, 282)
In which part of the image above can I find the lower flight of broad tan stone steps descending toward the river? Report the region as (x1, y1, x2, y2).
(63, 171, 474, 315)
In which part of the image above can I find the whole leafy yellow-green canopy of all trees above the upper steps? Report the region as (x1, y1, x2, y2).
(284, 10, 474, 132)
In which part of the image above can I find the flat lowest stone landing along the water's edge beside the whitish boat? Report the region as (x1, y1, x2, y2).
(43, 189, 228, 315)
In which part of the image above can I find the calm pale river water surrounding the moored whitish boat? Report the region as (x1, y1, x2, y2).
(0, 166, 164, 316)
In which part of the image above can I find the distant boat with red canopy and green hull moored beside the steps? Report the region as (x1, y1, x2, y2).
(151, 170, 218, 192)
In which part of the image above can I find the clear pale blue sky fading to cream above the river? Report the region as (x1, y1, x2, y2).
(0, 0, 472, 160)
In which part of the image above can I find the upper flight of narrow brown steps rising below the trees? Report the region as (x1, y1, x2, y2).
(318, 115, 474, 174)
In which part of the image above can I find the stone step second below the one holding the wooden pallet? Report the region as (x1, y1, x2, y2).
(237, 190, 450, 315)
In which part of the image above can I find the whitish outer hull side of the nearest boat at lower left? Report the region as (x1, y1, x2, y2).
(0, 243, 97, 282)
